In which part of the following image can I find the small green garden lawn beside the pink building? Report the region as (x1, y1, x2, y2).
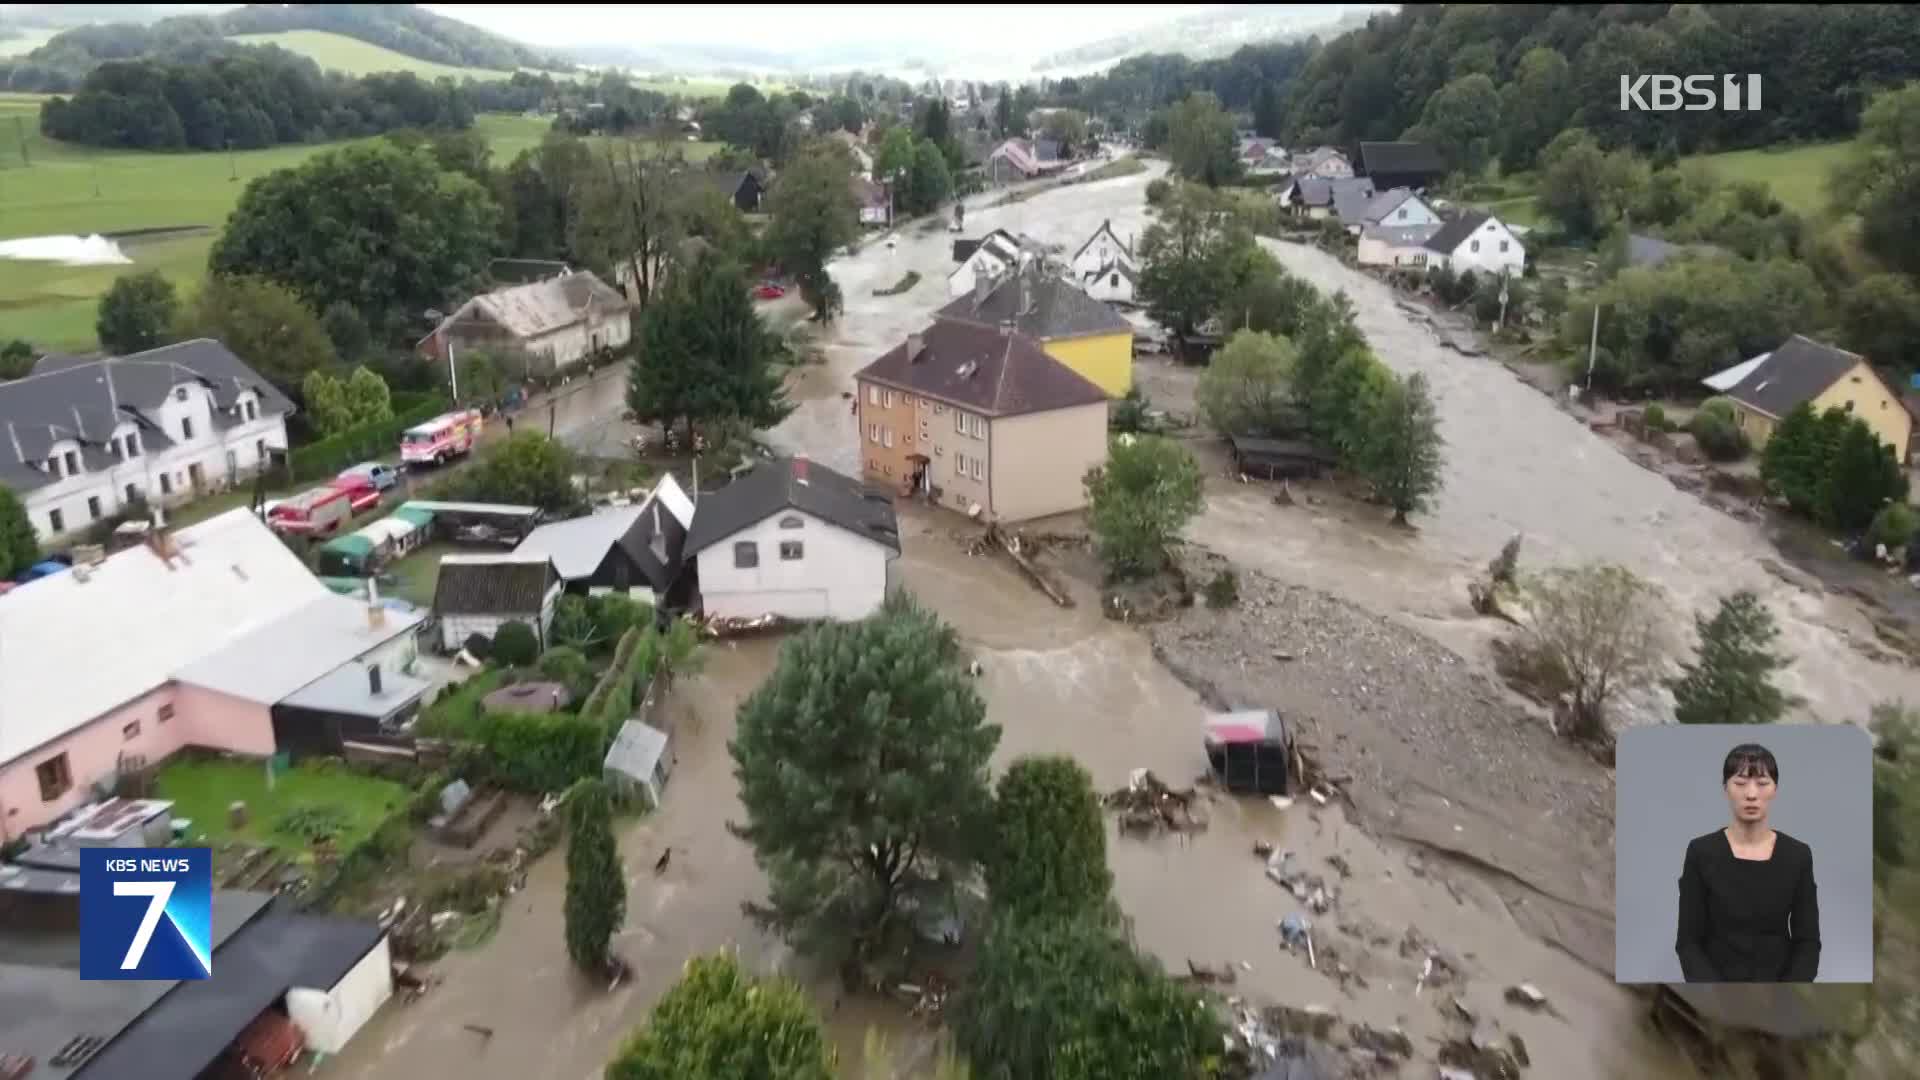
(156, 759, 413, 859)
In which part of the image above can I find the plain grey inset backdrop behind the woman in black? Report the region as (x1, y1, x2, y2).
(1613, 724, 1874, 982)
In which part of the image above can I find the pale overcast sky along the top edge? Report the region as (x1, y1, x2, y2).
(424, 4, 1228, 56)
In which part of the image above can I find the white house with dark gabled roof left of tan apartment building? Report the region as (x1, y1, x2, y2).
(685, 457, 900, 619)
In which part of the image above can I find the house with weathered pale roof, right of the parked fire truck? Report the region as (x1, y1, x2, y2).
(415, 271, 634, 377)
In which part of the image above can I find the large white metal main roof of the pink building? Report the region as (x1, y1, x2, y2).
(0, 509, 330, 763)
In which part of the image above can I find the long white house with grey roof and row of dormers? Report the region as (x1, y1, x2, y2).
(0, 338, 294, 540)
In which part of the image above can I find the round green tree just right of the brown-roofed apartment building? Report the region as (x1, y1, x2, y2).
(1087, 434, 1206, 580)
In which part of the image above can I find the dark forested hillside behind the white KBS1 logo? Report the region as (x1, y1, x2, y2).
(1274, 4, 1920, 171)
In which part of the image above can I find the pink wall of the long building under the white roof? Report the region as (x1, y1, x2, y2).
(0, 682, 273, 840)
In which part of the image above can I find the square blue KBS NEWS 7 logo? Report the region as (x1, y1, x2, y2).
(81, 847, 213, 980)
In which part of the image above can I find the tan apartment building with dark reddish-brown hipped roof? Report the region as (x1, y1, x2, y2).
(854, 319, 1108, 521)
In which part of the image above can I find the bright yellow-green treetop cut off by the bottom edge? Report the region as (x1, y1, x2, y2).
(607, 953, 835, 1080)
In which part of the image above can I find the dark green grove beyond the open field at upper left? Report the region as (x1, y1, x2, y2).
(40, 46, 474, 150)
